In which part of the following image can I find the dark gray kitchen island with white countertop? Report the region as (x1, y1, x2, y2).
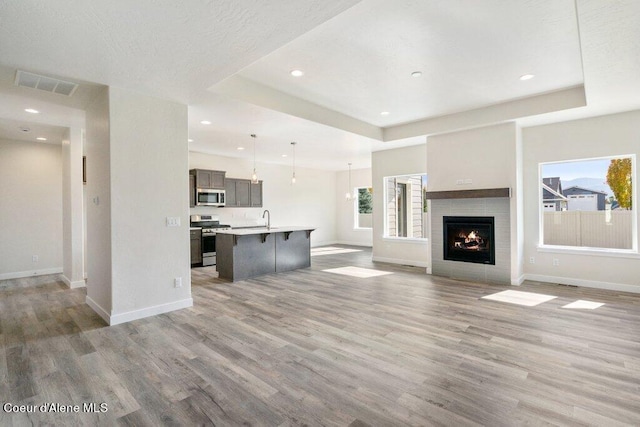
(216, 227, 314, 282)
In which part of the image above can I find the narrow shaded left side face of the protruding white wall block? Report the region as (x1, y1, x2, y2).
(84, 88, 112, 322)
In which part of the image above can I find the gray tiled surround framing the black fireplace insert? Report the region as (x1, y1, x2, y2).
(431, 196, 511, 284)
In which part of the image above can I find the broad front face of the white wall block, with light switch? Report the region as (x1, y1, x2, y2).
(107, 87, 193, 324)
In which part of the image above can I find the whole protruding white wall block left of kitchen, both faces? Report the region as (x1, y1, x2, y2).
(86, 87, 193, 325)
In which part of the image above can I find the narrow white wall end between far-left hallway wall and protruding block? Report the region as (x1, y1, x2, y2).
(62, 127, 85, 288)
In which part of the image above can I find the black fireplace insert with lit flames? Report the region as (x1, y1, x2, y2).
(442, 216, 496, 265)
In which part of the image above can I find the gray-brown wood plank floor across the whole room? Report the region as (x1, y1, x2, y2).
(0, 250, 640, 427)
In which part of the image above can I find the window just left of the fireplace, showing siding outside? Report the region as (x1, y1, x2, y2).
(384, 174, 429, 239)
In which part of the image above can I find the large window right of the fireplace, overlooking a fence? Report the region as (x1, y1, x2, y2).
(540, 155, 637, 250)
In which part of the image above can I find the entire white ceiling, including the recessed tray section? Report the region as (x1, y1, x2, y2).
(0, 0, 640, 170)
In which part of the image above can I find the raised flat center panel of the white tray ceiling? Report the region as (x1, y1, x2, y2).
(231, 0, 582, 127)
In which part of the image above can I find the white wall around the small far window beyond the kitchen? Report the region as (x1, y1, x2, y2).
(335, 169, 373, 247)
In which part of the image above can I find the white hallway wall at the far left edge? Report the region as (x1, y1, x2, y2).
(0, 140, 62, 279)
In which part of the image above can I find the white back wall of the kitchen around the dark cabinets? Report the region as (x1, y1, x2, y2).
(190, 152, 337, 246)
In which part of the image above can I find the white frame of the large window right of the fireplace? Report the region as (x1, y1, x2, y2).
(536, 154, 640, 254)
